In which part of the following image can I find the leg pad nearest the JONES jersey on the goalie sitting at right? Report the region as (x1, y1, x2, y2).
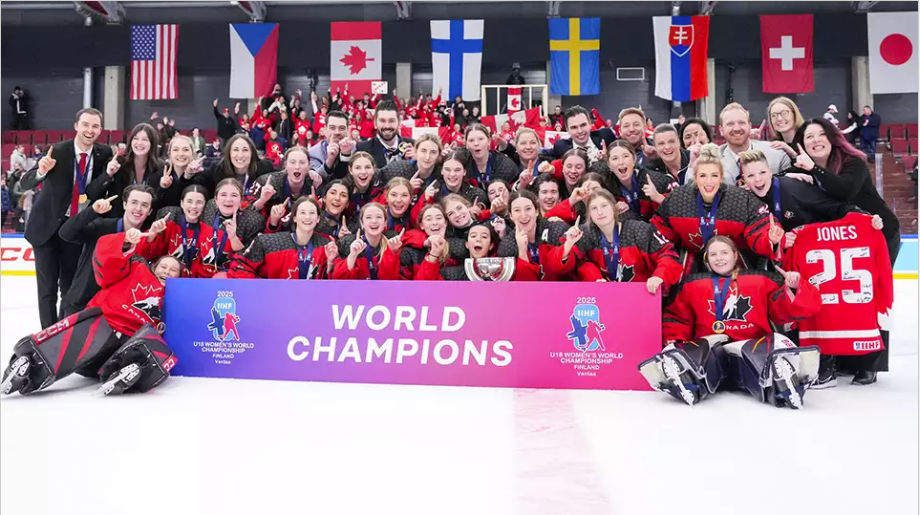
(725, 333, 821, 409)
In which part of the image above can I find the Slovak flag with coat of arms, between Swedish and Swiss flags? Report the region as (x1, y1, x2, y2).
(652, 16, 709, 102)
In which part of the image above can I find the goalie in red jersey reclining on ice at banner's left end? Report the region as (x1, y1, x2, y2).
(0, 230, 181, 395)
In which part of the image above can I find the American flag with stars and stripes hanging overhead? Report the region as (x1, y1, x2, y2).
(131, 25, 179, 100)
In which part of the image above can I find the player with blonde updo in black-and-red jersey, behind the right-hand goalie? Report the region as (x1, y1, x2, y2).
(652, 143, 785, 270)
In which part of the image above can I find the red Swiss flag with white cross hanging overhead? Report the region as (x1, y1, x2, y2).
(760, 14, 815, 93)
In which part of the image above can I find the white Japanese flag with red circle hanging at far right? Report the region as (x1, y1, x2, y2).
(868, 12, 918, 95)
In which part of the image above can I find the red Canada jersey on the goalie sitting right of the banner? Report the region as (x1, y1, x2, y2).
(662, 270, 821, 344)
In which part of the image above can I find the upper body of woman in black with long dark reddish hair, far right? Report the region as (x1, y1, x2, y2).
(795, 118, 901, 266)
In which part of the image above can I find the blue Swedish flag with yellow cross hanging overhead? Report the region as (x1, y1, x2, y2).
(549, 18, 601, 96)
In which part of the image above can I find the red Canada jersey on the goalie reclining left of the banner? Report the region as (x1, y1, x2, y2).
(86, 233, 171, 335)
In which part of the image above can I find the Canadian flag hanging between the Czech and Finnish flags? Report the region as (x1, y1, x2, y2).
(329, 21, 383, 97)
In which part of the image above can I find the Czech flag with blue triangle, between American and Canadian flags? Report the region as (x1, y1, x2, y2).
(230, 23, 278, 98)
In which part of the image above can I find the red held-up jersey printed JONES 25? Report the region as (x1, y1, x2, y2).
(784, 213, 894, 355)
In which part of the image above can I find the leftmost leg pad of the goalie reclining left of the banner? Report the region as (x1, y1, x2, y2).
(0, 308, 114, 395)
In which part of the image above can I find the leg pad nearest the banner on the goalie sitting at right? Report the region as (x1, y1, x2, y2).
(639, 336, 727, 406)
